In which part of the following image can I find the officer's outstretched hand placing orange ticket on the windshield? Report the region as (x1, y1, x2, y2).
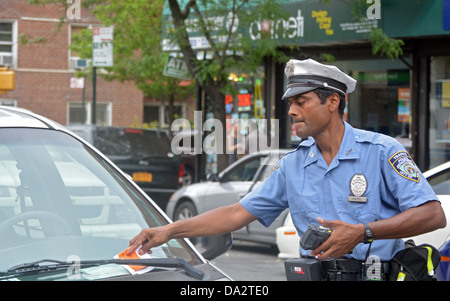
(127, 227, 169, 255)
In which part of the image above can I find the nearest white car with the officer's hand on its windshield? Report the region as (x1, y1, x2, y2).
(0, 106, 231, 281)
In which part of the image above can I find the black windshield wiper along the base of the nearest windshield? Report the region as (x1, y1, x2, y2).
(0, 258, 204, 280)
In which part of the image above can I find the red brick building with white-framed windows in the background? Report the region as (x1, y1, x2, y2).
(0, 0, 144, 126)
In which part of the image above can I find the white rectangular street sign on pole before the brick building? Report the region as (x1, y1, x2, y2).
(92, 27, 114, 67)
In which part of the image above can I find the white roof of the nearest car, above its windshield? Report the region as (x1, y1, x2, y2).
(0, 106, 64, 130)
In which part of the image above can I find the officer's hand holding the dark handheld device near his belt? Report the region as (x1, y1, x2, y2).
(311, 217, 364, 259)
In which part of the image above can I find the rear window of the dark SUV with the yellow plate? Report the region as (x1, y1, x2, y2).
(93, 127, 171, 158)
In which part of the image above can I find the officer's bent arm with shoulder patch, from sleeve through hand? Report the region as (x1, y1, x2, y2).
(312, 143, 447, 258)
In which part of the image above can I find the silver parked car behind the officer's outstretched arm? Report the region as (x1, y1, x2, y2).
(166, 149, 289, 246)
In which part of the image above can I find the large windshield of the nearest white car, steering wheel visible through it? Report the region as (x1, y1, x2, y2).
(0, 128, 199, 278)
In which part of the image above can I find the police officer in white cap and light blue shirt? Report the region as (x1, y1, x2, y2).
(129, 59, 446, 276)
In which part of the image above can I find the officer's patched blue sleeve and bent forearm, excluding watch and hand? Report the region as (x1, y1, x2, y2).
(369, 145, 447, 239)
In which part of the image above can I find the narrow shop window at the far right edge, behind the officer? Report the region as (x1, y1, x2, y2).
(429, 56, 450, 168)
